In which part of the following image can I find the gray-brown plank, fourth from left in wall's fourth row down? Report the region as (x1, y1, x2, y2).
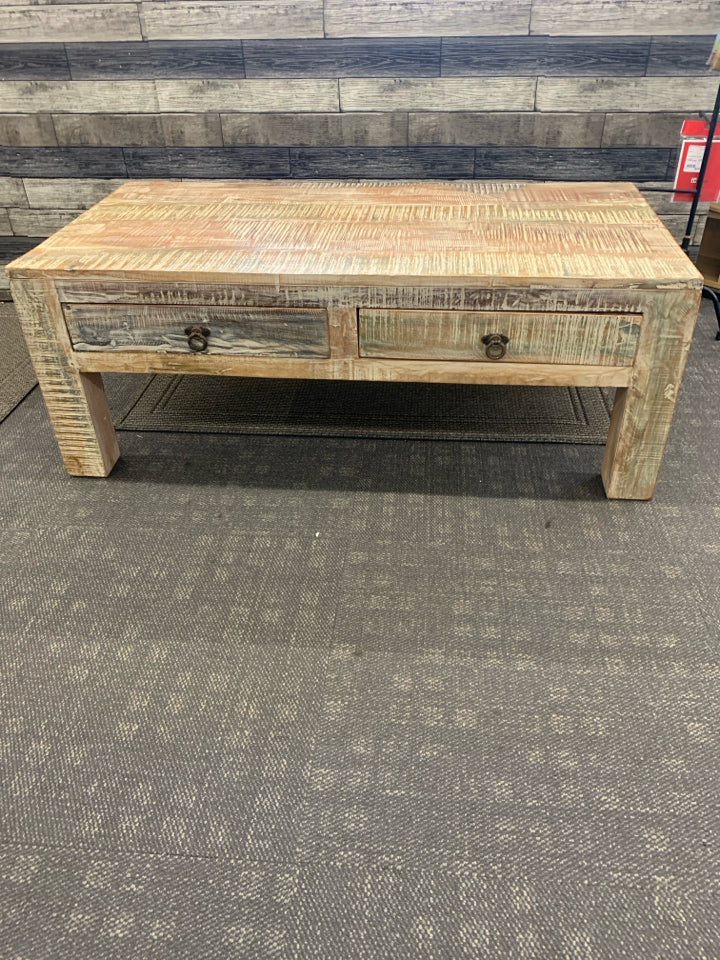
(408, 111, 604, 147)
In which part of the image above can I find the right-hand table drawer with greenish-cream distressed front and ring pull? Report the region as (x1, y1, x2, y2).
(359, 309, 642, 367)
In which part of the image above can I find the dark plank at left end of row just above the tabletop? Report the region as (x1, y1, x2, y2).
(0, 147, 127, 177)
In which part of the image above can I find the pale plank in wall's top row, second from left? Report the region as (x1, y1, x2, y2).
(140, 0, 323, 40)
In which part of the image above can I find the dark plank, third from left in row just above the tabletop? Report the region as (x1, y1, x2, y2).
(290, 147, 473, 179)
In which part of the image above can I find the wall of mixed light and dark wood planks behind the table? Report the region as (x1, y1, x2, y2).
(0, 0, 718, 290)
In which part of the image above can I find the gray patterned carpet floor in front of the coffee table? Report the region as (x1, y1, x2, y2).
(0, 303, 720, 960)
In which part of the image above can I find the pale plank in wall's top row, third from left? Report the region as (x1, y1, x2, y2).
(325, 0, 530, 37)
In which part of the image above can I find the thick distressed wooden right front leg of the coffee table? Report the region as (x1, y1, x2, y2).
(602, 288, 701, 500)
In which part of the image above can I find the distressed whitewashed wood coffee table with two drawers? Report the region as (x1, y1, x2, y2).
(7, 181, 702, 499)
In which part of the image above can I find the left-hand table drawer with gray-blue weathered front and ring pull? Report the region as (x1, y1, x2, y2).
(63, 303, 330, 357)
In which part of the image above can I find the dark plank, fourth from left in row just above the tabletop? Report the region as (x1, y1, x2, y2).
(475, 147, 671, 180)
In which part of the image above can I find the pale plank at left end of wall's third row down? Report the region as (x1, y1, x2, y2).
(0, 80, 158, 113)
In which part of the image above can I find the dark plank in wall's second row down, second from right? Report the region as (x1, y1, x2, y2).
(441, 37, 650, 77)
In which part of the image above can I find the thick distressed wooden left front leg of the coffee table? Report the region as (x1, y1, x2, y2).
(10, 279, 120, 477)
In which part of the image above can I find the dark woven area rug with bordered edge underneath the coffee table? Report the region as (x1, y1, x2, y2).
(105, 374, 614, 444)
